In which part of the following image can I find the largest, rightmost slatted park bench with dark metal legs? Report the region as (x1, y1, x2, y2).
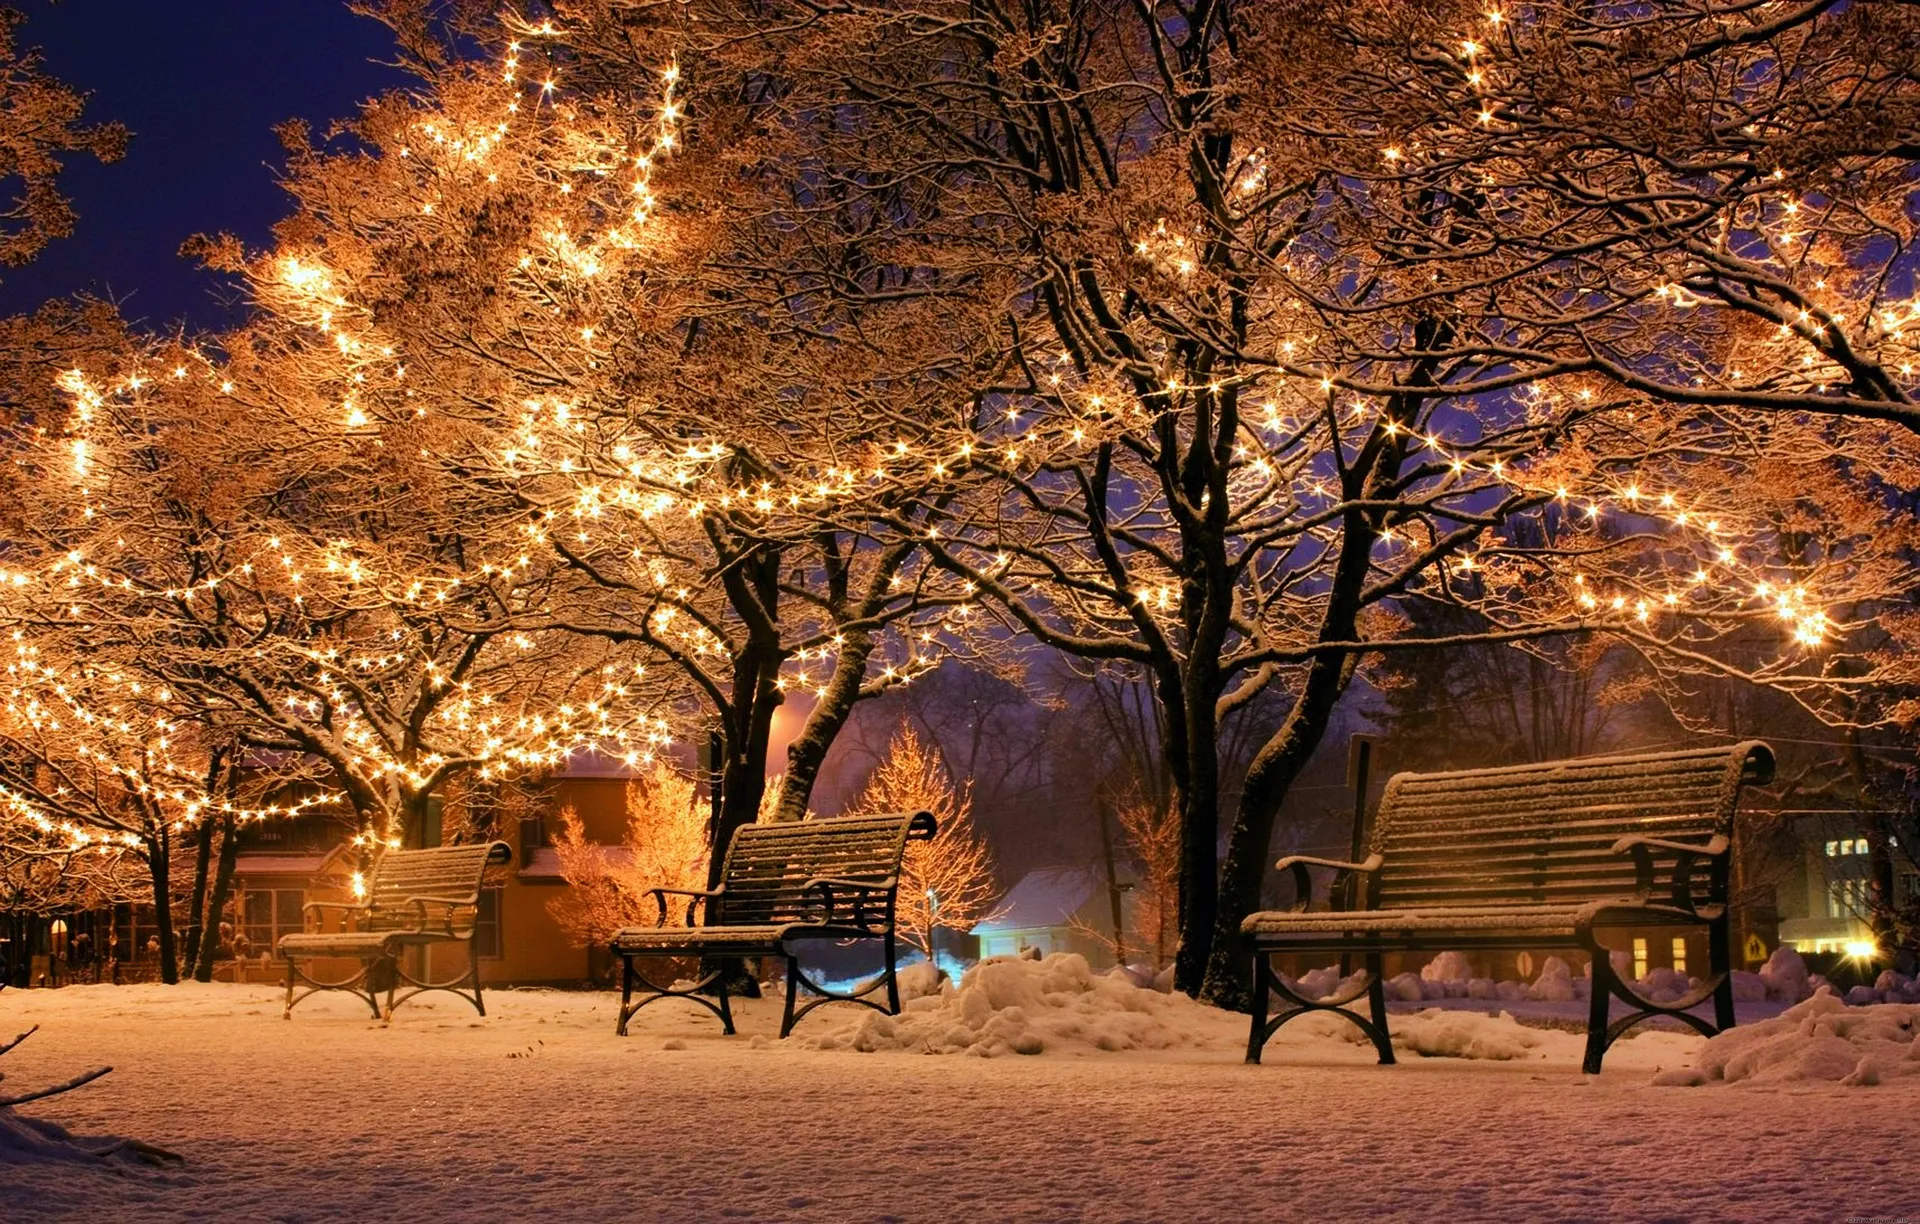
(1240, 741, 1774, 1074)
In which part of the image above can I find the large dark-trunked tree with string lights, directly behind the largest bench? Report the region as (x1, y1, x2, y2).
(645, 2, 1907, 1001)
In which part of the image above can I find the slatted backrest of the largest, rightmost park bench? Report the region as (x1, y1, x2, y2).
(1369, 741, 1774, 909)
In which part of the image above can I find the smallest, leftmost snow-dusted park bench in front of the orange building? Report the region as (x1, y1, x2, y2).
(278, 842, 513, 1019)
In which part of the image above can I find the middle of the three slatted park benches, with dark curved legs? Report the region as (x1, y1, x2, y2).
(612, 812, 937, 1036)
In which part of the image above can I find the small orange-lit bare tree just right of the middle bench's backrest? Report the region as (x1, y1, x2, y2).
(847, 727, 1000, 961)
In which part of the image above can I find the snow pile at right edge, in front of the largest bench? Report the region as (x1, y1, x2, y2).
(1653, 990, 1920, 1088)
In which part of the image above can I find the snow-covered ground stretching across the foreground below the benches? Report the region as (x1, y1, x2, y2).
(0, 957, 1920, 1224)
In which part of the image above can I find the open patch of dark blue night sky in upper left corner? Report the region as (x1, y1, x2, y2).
(0, 0, 405, 328)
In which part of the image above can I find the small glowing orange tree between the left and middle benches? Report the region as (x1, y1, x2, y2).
(547, 764, 707, 946)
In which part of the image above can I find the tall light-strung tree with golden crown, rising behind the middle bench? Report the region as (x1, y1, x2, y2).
(228, 4, 990, 890)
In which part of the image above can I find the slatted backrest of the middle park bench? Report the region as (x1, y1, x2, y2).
(707, 812, 935, 927)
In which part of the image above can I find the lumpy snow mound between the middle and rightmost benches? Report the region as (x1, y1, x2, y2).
(797, 952, 1246, 1057)
